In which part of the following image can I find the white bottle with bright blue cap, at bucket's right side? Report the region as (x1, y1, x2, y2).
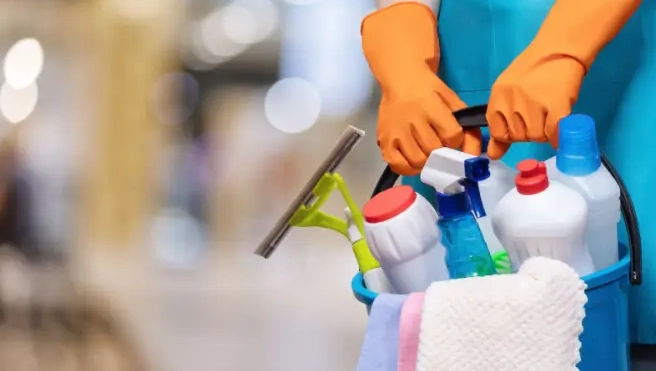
(546, 114, 621, 270)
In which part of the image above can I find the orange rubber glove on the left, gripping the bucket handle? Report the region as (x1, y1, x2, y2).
(362, 2, 481, 175)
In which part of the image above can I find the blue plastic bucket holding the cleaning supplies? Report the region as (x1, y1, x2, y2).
(351, 246, 630, 371)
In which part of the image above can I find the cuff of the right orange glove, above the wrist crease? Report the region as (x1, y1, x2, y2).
(532, 0, 641, 70)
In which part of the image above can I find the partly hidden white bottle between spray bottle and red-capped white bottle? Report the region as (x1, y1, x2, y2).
(477, 136, 516, 254)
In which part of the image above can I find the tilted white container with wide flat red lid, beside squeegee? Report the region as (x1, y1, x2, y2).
(362, 186, 449, 294)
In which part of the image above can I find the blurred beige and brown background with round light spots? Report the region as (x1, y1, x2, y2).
(0, 0, 383, 371)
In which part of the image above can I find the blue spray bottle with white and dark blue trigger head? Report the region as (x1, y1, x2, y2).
(421, 148, 496, 278)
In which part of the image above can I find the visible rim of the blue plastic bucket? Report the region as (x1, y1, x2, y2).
(351, 244, 631, 306)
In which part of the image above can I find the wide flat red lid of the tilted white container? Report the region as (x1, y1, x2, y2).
(362, 186, 417, 224)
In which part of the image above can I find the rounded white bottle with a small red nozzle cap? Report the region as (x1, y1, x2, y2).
(492, 160, 594, 276)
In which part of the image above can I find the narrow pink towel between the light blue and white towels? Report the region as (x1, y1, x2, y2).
(397, 292, 424, 371)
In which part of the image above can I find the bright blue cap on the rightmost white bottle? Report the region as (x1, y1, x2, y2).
(556, 114, 601, 176)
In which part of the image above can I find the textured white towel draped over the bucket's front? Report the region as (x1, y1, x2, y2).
(417, 257, 587, 371)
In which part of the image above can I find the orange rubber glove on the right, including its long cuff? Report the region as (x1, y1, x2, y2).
(487, 0, 640, 159)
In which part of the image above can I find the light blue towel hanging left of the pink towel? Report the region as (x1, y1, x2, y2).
(356, 294, 407, 371)
